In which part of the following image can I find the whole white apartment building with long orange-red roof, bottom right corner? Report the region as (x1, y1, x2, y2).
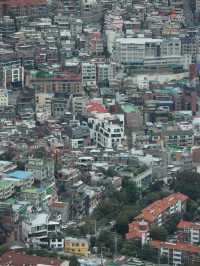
(150, 240, 200, 266)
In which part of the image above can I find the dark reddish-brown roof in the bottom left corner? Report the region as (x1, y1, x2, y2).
(0, 250, 62, 266)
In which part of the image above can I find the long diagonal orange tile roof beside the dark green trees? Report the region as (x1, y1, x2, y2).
(135, 192, 188, 223)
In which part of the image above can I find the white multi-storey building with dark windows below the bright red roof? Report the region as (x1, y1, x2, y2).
(89, 113, 125, 148)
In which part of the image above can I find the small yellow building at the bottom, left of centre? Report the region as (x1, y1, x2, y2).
(65, 237, 89, 257)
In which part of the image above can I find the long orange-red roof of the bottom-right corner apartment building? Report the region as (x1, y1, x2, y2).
(150, 240, 200, 253)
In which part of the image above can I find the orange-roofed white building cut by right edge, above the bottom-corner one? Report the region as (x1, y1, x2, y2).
(177, 220, 200, 244)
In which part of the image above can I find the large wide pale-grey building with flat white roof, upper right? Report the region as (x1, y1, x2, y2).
(113, 38, 188, 66)
